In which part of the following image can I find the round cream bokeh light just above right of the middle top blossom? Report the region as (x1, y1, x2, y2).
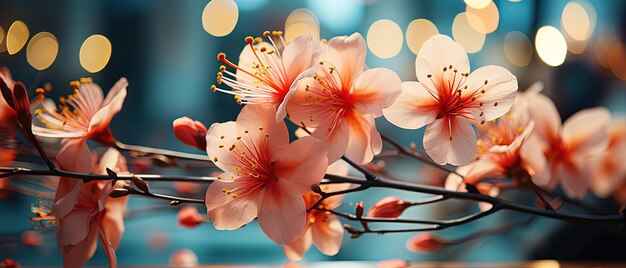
(367, 19, 404, 59)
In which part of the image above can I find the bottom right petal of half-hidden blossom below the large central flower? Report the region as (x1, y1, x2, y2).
(311, 215, 343, 256)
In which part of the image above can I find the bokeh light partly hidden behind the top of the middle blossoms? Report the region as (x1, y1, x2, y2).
(285, 8, 320, 42)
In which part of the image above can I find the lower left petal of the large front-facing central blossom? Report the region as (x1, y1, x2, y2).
(205, 178, 262, 230)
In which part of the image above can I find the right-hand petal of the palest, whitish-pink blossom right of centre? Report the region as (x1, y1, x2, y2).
(463, 65, 517, 121)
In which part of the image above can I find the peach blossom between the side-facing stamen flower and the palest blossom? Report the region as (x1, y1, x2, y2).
(287, 33, 401, 164)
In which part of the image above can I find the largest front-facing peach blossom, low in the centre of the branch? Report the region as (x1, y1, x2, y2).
(205, 105, 328, 244)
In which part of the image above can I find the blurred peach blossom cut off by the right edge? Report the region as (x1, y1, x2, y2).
(591, 118, 626, 204)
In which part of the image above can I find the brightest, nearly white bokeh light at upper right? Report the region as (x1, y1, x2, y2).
(535, 26, 567, 66)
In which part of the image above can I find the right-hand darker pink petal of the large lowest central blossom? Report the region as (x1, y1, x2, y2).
(272, 137, 328, 194)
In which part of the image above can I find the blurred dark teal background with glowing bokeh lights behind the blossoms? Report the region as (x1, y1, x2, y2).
(0, 0, 626, 265)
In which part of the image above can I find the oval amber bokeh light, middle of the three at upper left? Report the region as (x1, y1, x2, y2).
(26, 32, 59, 71)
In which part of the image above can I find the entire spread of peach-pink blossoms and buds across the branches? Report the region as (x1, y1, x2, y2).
(0, 32, 626, 267)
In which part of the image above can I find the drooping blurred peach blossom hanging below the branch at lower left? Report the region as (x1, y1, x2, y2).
(47, 148, 128, 267)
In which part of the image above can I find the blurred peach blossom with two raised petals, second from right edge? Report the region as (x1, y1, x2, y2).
(529, 94, 611, 199)
